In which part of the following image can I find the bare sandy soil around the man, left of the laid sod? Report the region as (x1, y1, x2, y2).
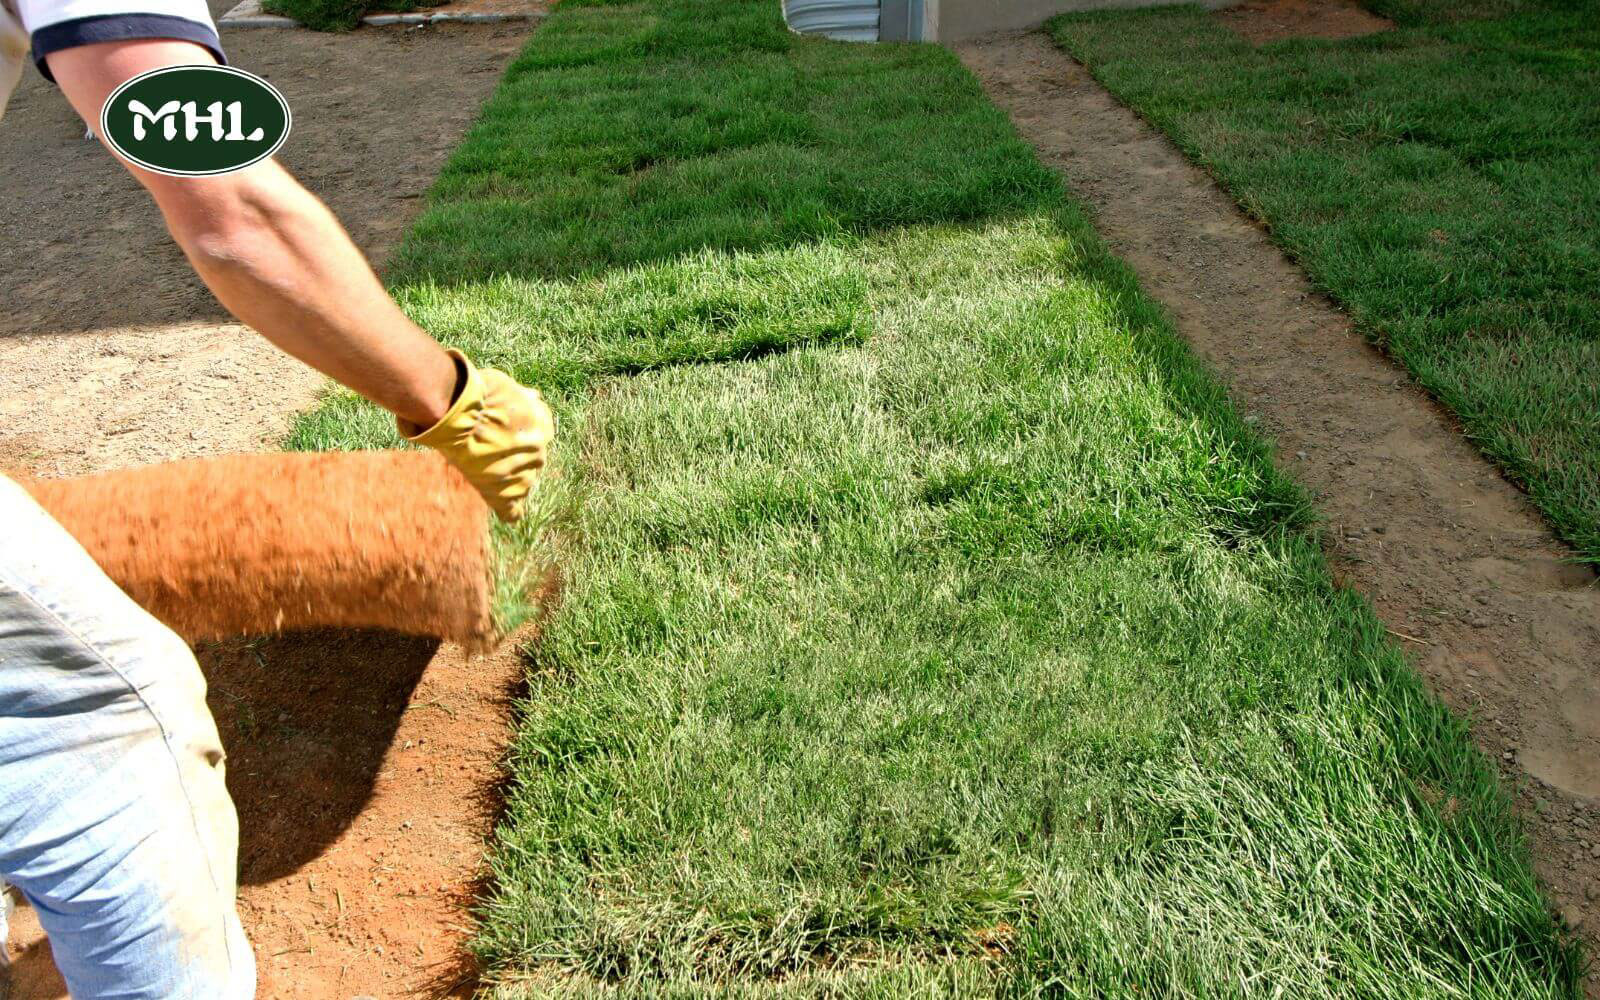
(0, 9, 533, 998)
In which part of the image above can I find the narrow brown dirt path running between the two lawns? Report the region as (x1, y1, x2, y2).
(957, 34, 1600, 997)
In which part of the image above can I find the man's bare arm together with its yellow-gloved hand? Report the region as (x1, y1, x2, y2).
(45, 38, 555, 520)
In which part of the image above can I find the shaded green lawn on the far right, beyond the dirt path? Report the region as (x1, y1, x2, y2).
(1053, 0, 1600, 563)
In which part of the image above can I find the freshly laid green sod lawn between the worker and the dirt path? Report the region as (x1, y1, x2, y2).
(296, 0, 1579, 1000)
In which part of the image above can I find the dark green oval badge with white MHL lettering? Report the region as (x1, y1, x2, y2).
(99, 66, 291, 178)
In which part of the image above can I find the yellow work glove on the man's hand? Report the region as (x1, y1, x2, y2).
(395, 350, 555, 522)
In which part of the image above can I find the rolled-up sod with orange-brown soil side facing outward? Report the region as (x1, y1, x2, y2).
(19, 451, 494, 650)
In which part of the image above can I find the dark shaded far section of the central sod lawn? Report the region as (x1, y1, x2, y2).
(377, 0, 1058, 288)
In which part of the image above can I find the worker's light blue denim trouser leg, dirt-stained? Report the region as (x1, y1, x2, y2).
(0, 477, 256, 1000)
